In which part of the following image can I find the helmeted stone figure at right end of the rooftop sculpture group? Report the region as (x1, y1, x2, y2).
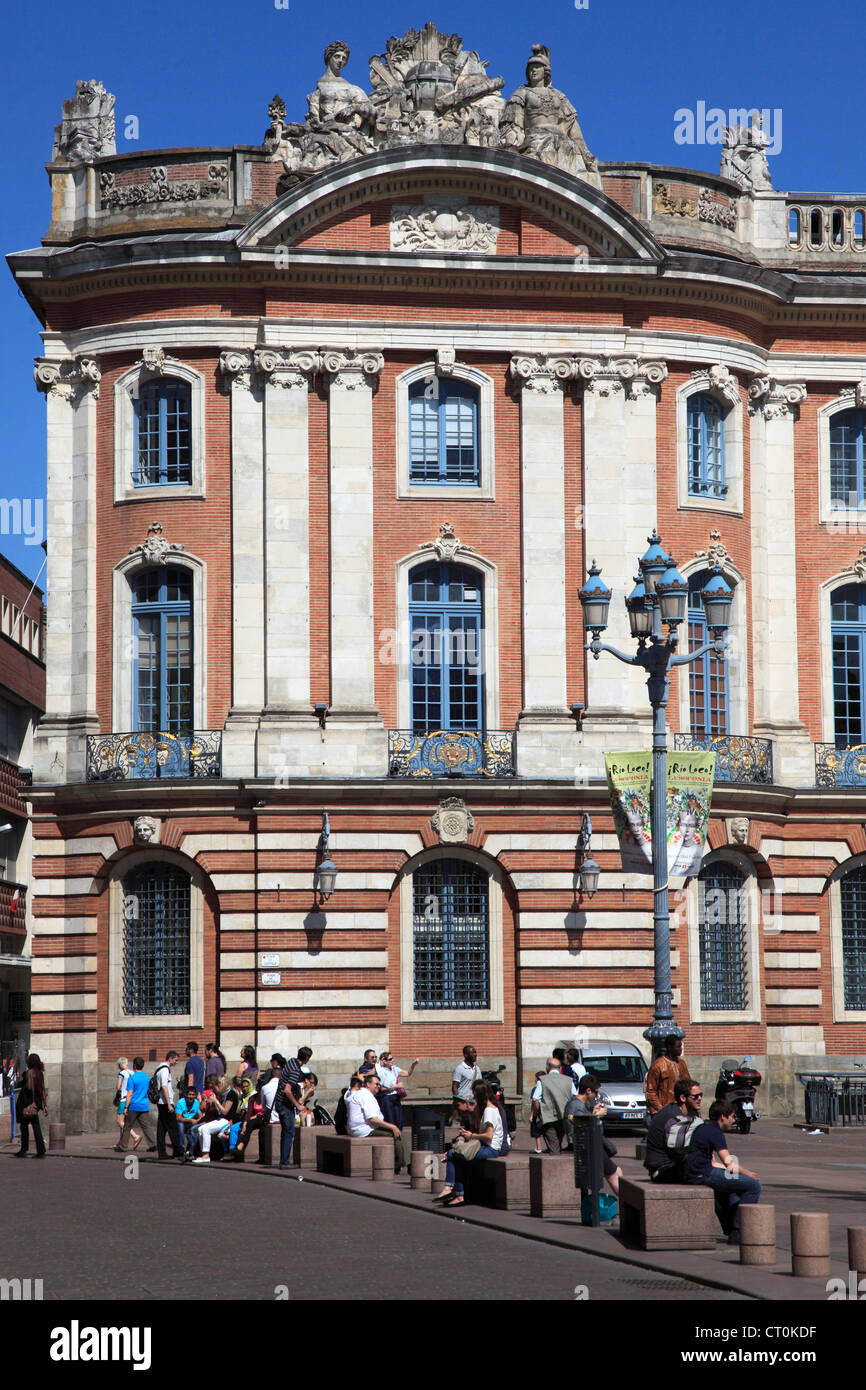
(499, 43, 598, 175)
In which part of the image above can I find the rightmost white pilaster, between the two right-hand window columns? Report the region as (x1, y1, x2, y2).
(749, 377, 815, 785)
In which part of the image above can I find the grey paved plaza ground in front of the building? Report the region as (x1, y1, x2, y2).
(0, 1120, 866, 1302)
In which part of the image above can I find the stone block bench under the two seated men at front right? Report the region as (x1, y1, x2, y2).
(620, 1177, 720, 1250)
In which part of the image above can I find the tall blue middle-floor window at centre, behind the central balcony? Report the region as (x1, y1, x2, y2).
(409, 562, 484, 734)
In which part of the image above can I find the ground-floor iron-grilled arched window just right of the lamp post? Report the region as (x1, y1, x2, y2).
(698, 860, 749, 1011)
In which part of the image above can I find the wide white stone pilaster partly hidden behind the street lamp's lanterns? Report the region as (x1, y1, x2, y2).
(575, 357, 667, 771)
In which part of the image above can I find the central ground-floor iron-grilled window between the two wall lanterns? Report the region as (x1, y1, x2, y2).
(413, 859, 491, 1009)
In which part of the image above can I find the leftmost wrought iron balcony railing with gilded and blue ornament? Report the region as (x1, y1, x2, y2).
(88, 728, 222, 781)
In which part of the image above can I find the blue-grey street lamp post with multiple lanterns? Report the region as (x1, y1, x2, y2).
(578, 531, 734, 1056)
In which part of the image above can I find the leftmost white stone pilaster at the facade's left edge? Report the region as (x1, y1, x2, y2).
(33, 357, 100, 781)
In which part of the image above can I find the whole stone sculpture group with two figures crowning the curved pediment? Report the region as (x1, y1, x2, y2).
(264, 22, 596, 192)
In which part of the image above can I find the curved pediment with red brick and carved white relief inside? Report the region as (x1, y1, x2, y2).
(238, 146, 664, 261)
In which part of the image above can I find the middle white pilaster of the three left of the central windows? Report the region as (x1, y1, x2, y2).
(256, 349, 318, 721)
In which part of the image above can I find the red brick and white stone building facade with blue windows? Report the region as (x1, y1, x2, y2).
(10, 25, 866, 1127)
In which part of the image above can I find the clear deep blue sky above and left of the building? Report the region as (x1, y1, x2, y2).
(0, 0, 866, 577)
